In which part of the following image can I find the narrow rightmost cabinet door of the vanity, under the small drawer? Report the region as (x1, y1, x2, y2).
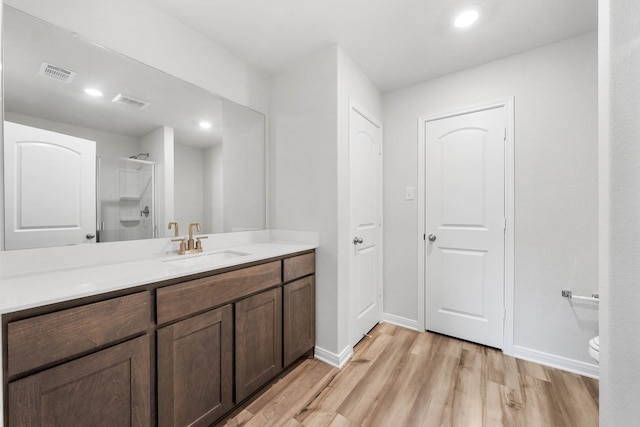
(283, 276, 316, 366)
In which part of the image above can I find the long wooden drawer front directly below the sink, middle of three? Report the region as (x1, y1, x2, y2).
(156, 261, 281, 325)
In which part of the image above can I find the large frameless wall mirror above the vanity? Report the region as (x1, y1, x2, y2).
(2, 6, 267, 249)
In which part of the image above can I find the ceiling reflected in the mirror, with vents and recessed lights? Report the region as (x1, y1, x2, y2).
(2, 6, 223, 148)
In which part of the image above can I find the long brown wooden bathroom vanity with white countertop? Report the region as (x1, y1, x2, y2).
(2, 243, 315, 426)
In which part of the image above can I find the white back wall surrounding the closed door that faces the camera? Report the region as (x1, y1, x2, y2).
(383, 34, 598, 371)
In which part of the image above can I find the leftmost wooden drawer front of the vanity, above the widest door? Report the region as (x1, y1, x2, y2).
(7, 291, 151, 376)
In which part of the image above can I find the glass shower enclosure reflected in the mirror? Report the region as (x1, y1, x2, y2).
(97, 157, 157, 242)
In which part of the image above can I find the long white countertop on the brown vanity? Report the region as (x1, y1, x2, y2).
(0, 231, 317, 314)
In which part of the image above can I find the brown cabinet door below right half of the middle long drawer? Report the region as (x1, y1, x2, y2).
(236, 288, 282, 402)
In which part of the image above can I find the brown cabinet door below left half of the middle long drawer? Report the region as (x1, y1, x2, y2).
(158, 305, 233, 427)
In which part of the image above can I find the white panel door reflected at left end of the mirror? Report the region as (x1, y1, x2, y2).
(4, 122, 96, 249)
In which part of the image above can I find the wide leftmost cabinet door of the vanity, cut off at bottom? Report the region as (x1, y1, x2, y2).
(8, 336, 151, 427)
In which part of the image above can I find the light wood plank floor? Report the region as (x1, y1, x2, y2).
(220, 323, 598, 427)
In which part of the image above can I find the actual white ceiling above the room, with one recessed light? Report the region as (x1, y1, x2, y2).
(142, 0, 598, 91)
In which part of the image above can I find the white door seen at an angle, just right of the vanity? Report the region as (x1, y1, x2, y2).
(349, 105, 382, 345)
